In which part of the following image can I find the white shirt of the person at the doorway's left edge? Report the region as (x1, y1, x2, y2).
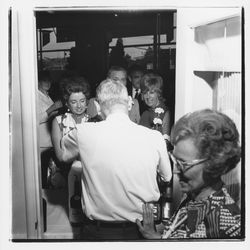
(38, 90, 54, 148)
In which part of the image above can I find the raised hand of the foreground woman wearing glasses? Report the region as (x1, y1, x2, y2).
(136, 203, 161, 239)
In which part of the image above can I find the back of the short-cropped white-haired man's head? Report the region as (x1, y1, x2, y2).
(96, 79, 129, 115)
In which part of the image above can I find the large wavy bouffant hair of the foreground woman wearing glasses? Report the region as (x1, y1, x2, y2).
(171, 109, 241, 183)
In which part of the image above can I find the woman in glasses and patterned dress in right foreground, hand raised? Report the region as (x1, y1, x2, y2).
(137, 109, 241, 239)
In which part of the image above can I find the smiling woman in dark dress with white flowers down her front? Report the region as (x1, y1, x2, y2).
(139, 73, 170, 146)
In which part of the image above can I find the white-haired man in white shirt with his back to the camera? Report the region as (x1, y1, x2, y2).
(60, 79, 172, 240)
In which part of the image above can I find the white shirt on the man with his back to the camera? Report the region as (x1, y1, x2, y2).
(62, 114, 172, 222)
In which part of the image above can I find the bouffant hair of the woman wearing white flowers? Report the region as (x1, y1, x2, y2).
(140, 72, 163, 100)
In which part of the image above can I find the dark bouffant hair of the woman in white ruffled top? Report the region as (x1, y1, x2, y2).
(60, 76, 90, 103)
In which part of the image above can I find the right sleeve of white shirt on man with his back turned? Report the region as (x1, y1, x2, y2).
(154, 131, 172, 182)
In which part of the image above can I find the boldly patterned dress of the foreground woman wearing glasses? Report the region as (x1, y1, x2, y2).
(162, 187, 241, 239)
